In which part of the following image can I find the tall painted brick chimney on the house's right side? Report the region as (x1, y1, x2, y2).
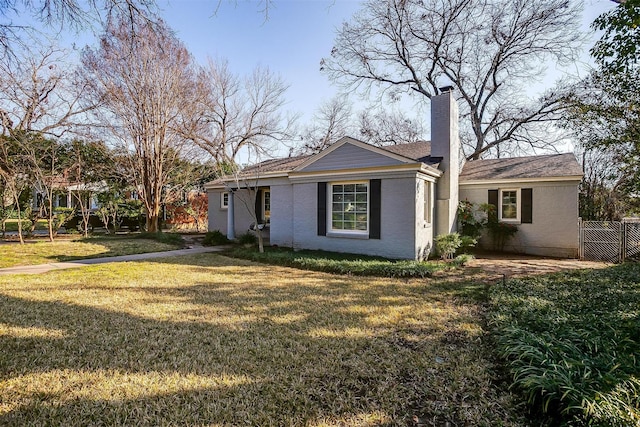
(431, 86, 460, 236)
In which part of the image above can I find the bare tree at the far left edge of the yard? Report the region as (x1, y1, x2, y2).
(0, 44, 93, 240)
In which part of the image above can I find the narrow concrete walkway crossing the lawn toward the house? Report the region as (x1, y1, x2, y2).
(0, 246, 224, 276)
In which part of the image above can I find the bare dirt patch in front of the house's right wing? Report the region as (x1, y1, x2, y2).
(467, 254, 612, 279)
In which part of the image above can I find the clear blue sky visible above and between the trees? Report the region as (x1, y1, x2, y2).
(0, 0, 615, 154)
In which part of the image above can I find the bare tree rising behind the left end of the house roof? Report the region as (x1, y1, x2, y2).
(183, 59, 295, 163)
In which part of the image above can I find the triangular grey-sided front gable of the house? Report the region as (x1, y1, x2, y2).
(296, 137, 415, 172)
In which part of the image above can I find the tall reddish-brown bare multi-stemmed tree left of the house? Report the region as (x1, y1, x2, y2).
(82, 21, 198, 232)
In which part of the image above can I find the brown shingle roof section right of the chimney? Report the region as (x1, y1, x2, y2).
(460, 153, 582, 182)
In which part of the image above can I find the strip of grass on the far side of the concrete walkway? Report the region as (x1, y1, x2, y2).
(0, 233, 182, 268)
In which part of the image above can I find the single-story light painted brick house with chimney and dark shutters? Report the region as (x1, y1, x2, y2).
(205, 91, 582, 259)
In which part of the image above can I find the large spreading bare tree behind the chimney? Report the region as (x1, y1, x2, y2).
(322, 0, 581, 159)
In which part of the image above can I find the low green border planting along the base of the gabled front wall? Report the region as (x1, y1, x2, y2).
(222, 247, 447, 278)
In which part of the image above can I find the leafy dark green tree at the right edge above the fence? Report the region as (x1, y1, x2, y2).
(565, 0, 640, 219)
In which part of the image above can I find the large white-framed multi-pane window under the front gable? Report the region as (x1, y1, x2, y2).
(331, 182, 369, 233)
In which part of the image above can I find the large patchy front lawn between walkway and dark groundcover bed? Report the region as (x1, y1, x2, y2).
(0, 254, 522, 426)
